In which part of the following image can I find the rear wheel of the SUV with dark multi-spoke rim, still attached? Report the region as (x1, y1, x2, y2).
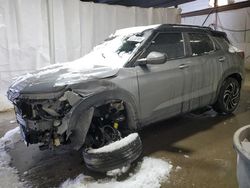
(213, 77, 240, 114)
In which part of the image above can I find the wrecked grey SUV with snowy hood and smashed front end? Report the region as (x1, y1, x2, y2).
(8, 24, 244, 170)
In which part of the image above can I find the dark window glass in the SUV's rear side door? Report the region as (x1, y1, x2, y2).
(188, 33, 214, 56)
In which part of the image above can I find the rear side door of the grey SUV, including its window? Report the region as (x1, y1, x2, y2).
(183, 32, 225, 112)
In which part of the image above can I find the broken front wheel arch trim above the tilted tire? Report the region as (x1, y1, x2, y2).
(67, 90, 139, 149)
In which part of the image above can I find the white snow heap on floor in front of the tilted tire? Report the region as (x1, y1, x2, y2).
(61, 157, 173, 188)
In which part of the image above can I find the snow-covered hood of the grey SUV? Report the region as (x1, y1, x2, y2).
(10, 61, 119, 94)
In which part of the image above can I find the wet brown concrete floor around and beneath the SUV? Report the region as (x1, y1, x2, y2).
(0, 72, 250, 188)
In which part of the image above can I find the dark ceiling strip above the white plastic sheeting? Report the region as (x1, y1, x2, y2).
(81, 0, 194, 8)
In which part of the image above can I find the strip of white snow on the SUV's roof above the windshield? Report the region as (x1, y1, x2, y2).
(114, 24, 160, 35)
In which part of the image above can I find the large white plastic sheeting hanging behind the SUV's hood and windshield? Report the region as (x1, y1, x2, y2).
(0, 0, 180, 111)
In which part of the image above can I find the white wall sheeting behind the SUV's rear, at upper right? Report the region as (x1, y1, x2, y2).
(182, 7, 250, 69)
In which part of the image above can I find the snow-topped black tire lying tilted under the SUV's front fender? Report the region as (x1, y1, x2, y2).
(83, 133, 142, 172)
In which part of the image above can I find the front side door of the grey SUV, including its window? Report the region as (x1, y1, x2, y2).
(135, 32, 188, 124)
